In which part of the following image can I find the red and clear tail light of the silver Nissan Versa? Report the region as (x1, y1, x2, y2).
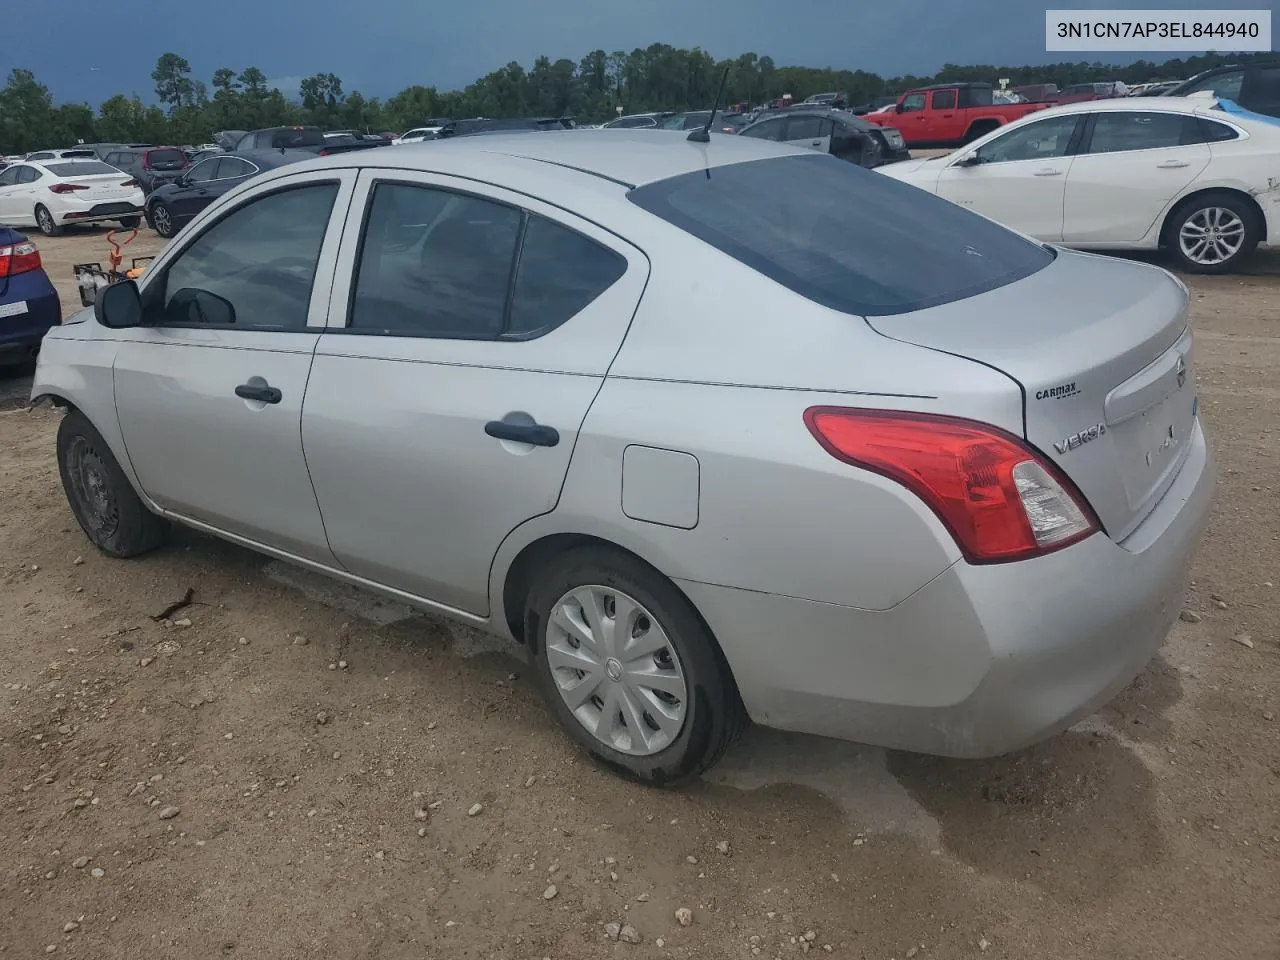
(804, 407, 1098, 563)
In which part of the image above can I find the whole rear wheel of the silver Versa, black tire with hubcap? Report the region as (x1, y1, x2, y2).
(525, 547, 746, 786)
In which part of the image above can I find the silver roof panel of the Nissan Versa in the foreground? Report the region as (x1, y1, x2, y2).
(291, 128, 805, 187)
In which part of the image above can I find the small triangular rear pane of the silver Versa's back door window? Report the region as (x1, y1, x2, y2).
(506, 216, 627, 339)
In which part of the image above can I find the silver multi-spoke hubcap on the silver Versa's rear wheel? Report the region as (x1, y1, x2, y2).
(545, 585, 689, 756)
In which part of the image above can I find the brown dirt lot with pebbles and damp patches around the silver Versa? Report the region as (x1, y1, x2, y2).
(0, 232, 1280, 960)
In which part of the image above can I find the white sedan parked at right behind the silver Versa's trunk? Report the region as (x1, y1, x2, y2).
(878, 97, 1280, 273)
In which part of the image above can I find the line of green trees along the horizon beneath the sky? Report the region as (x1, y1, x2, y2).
(0, 44, 1270, 154)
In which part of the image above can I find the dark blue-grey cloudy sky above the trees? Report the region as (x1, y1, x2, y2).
(10, 0, 1277, 104)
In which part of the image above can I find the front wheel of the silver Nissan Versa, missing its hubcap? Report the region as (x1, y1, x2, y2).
(58, 410, 168, 557)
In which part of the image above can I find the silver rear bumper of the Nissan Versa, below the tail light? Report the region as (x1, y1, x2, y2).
(681, 424, 1213, 756)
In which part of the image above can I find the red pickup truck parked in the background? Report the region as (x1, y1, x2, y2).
(863, 83, 1051, 147)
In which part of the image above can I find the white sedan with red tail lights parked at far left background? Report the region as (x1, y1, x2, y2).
(0, 160, 143, 237)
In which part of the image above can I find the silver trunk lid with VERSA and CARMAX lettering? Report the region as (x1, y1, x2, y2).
(868, 251, 1196, 540)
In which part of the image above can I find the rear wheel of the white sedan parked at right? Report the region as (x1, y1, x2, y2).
(1165, 193, 1262, 274)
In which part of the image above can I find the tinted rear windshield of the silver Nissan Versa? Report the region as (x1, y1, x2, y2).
(628, 154, 1053, 316)
